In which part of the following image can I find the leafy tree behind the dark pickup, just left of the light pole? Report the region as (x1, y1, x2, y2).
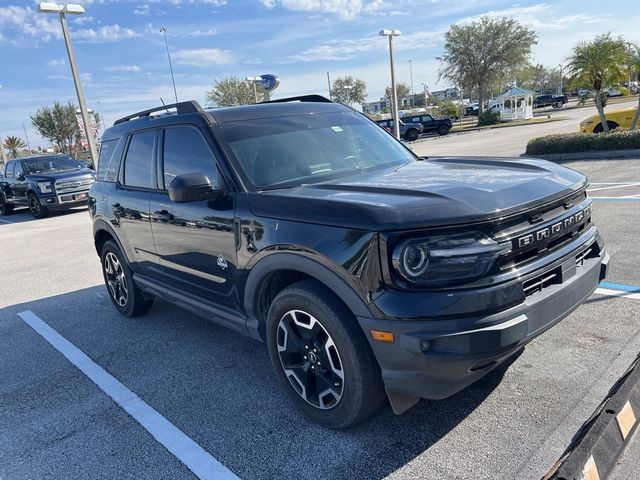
(31, 102, 81, 155)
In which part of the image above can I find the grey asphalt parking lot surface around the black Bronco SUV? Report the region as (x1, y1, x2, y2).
(0, 158, 640, 480)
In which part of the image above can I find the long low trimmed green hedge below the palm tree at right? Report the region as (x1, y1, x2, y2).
(526, 128, 640, 155)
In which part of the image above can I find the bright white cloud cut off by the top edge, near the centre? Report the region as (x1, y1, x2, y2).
(260, 0, 385, 20)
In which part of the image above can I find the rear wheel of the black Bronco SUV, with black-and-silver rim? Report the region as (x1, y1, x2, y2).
(100, 240, 153, 317)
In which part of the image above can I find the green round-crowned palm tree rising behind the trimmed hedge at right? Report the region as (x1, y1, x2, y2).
(568, 33, 627, 133)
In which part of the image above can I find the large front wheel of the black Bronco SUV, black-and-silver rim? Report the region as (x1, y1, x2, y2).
(267, 280, 384, 429)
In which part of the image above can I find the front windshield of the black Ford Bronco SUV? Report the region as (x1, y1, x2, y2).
(221, 112, 415, 190)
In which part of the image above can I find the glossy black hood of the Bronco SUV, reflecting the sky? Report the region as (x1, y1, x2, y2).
(249, 157, 587, 231)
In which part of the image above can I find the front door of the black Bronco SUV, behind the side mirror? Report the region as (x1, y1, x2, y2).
(150, 125, 237, 308)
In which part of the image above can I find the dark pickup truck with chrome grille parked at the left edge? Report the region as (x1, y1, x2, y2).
(0, 155, 94, 218)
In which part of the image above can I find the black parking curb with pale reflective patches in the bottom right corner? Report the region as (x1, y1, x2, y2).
(543, 355, 640, 480)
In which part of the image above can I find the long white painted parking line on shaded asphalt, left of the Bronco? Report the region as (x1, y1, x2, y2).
(18, 310, 238, 480)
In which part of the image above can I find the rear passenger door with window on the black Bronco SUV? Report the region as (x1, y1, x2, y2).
(107, 130, 158, 273)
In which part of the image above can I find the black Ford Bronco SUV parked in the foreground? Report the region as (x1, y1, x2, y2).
(89, 96, 609, 428)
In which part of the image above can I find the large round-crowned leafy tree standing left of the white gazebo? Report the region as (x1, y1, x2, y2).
(438, 17, 538, 112)
